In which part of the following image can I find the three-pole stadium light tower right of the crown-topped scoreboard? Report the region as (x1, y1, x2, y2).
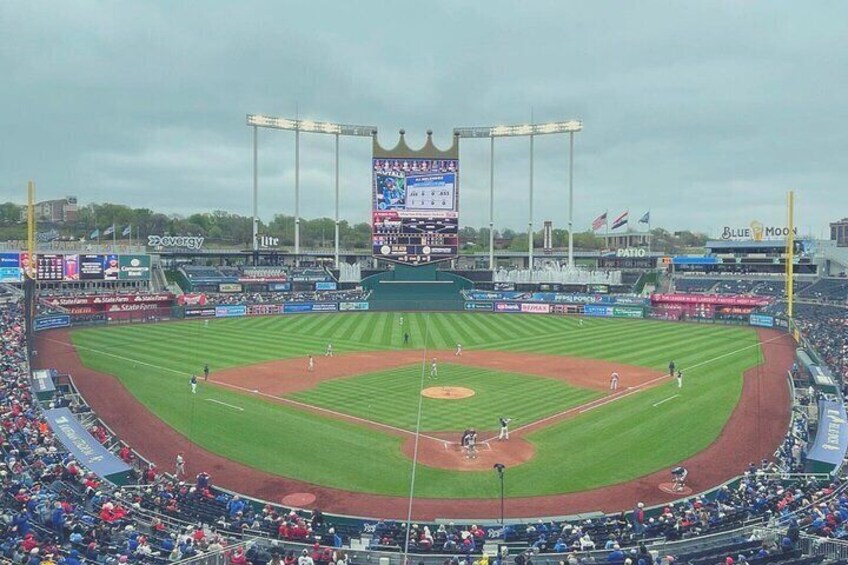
(453, 120, 583, 273)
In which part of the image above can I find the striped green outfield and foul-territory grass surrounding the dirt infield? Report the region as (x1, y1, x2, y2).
(71, 313, 760, 498)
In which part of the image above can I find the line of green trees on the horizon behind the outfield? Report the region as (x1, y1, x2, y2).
(0, 202, 707, 253)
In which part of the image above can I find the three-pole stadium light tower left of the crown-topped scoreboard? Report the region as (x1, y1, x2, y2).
(247, 114, 377, 269)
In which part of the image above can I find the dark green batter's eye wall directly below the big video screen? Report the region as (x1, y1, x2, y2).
(362, 265, 474, 311)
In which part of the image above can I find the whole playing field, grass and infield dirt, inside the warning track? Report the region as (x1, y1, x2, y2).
(44, 313, 782, 512)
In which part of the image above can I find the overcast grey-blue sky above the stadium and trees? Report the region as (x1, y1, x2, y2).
(0, 0, 848, 236)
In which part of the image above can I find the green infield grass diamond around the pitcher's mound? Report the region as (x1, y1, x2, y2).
(288, 363, 602, 432)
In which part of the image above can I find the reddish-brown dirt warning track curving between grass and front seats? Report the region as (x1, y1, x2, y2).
(35, 330, 795, 520)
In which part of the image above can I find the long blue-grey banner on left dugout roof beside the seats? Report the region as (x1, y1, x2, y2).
(44, 408, 132, 485)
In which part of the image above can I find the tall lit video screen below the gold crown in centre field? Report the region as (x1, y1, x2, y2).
(371, 158, 459, 265)
